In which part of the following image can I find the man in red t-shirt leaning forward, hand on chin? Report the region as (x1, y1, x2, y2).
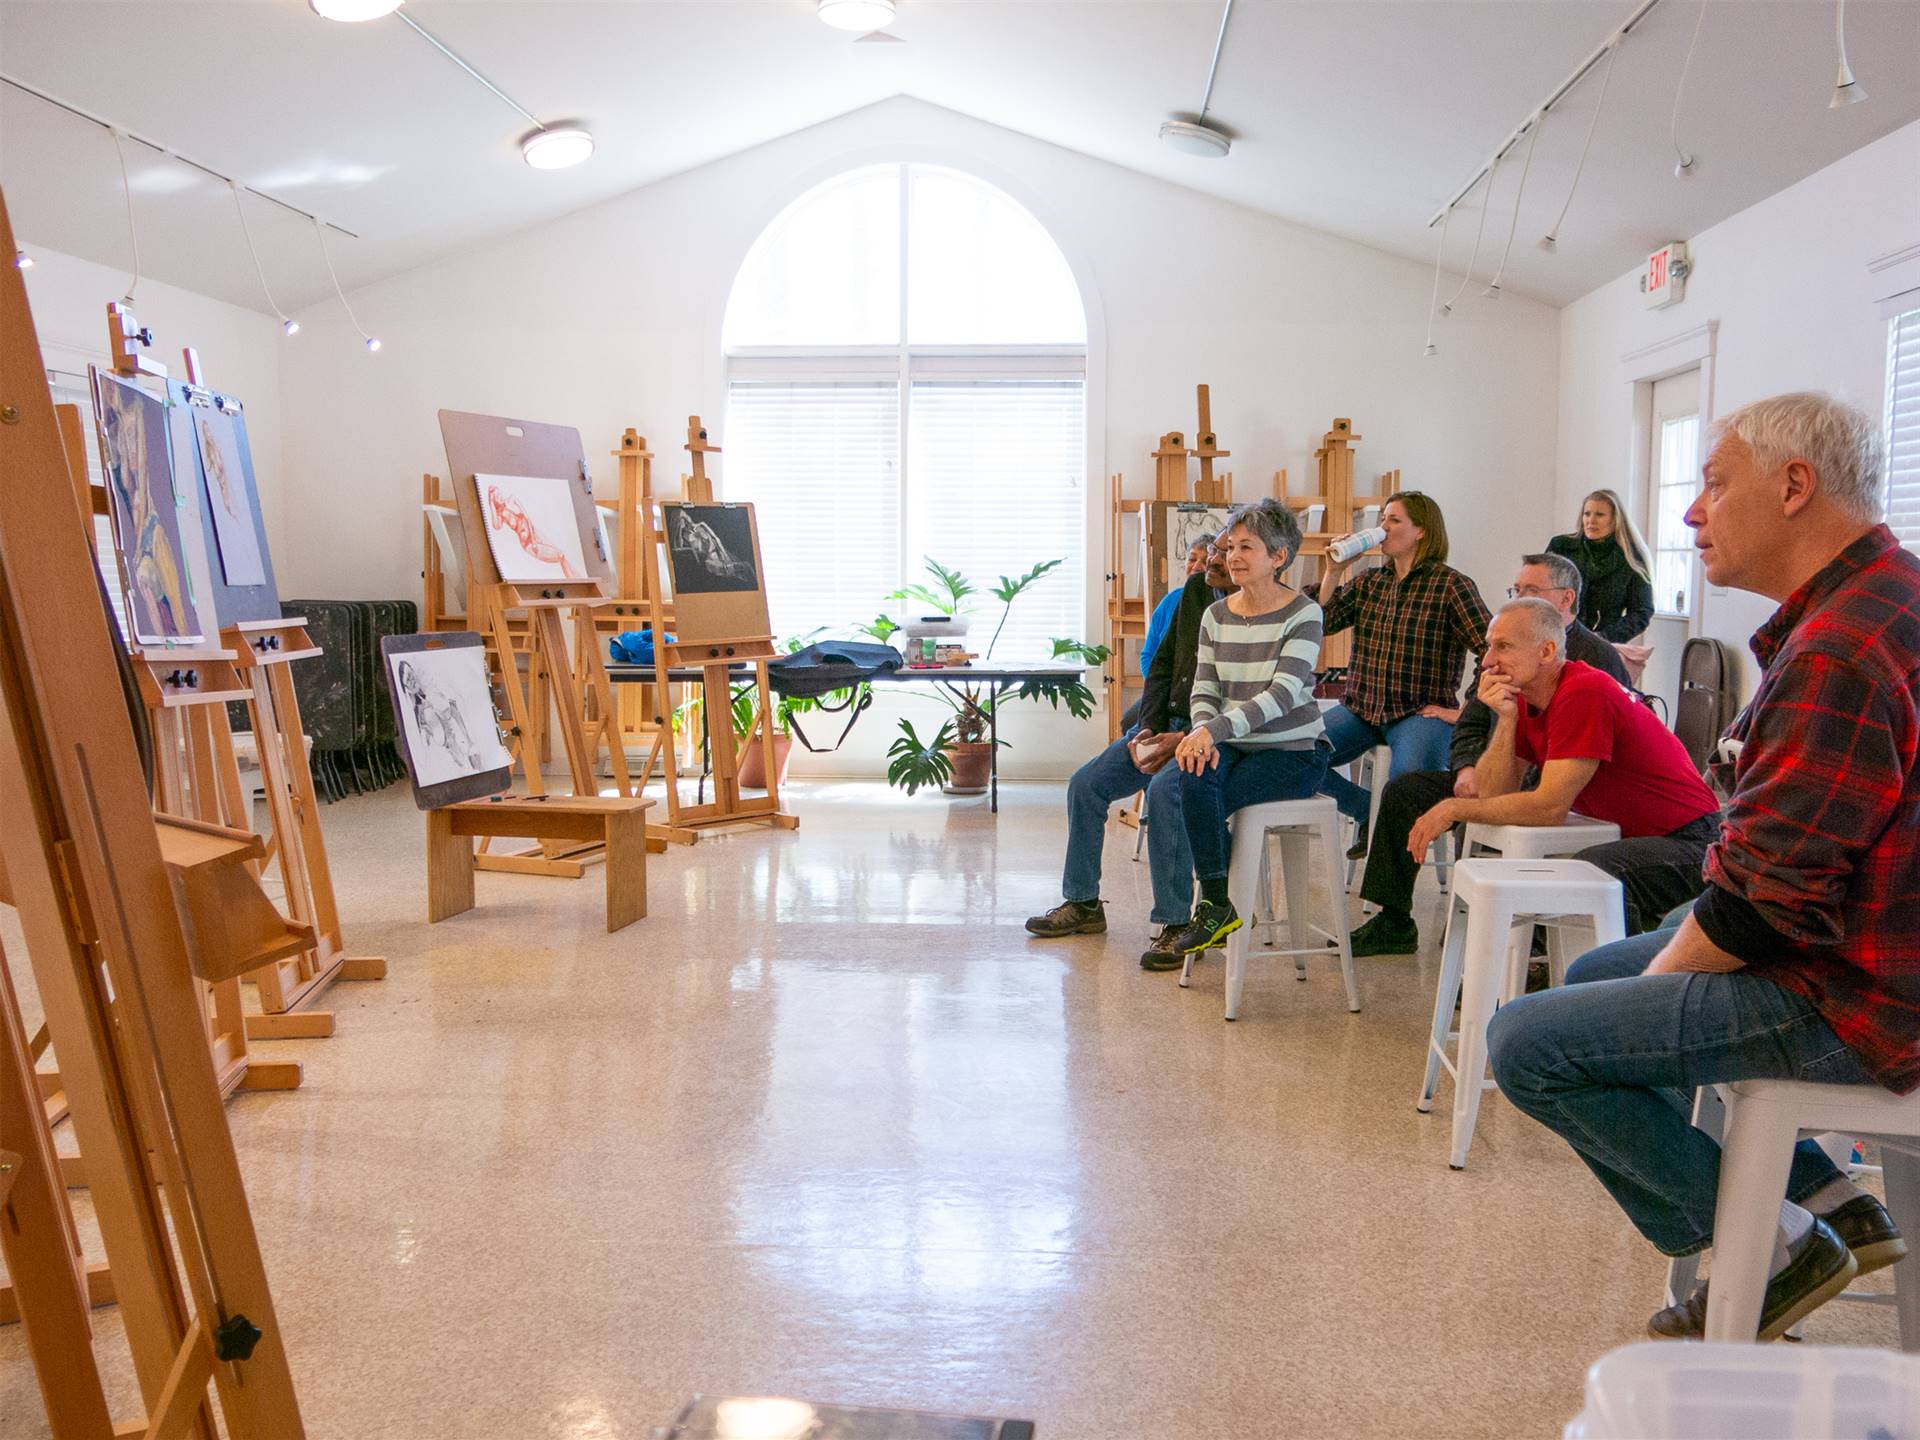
(1407, 599, 1720, 935)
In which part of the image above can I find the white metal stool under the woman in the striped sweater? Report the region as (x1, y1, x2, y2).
(1181, 795, 1359, 1020)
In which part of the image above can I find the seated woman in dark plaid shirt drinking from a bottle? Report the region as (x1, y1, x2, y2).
(1319, 490, 1490, 856)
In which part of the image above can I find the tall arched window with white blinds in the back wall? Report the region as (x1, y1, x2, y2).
(722, 163, 1087, 659)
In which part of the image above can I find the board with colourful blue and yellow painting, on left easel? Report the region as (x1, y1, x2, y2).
(90, 369, 207, 645)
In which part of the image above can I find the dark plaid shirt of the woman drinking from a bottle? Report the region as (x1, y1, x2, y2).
(1327, 561, 1492, 726)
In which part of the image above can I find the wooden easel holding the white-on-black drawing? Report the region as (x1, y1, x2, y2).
(622, 415, 801, 845)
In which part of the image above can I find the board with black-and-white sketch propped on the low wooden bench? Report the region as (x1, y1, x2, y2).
(380, 630, 513, 810)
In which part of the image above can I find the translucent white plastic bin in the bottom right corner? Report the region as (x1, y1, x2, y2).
(1565, 1340, 1920, 1440)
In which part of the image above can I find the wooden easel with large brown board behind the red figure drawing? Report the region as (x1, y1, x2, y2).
(440, 411, 634, 879)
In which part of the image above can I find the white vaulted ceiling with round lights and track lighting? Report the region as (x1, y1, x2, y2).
(0, 0, 1920, 309)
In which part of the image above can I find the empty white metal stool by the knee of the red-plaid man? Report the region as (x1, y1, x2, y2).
(1419, 858, 1626, 1169)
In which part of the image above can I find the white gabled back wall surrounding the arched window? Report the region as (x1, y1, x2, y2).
(269, 100, 1557, 776)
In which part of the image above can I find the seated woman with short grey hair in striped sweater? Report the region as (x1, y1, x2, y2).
(1140, 499, 1331, 970)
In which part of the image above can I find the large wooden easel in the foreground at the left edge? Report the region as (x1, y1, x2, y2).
(0, 198, 305, 1440)
